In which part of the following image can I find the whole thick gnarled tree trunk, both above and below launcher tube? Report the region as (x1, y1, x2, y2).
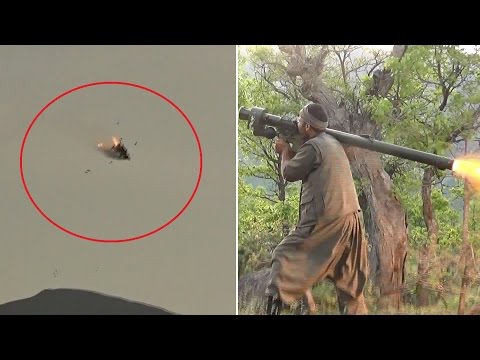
(279, 46, 407, 308)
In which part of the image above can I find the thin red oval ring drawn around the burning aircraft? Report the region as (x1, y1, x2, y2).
(20, 81, 203, 243)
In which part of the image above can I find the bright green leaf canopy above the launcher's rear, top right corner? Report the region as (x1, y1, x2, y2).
(384, 45, 480, 149)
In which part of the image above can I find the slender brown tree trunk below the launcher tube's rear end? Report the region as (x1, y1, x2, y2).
(416, 167, 438, 306)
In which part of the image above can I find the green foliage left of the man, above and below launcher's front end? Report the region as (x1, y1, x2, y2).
(238, 46, 302, 274)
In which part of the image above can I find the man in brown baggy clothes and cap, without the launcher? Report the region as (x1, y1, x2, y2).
(266, 104, 368, 314)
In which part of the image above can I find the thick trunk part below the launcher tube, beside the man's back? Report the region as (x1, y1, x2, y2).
(346, 147, 407, 309)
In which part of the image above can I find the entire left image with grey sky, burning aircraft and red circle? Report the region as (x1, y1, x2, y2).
(0, 45, 237, 315)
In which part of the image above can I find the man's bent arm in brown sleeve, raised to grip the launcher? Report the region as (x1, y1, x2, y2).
(281, 144, 316, 182)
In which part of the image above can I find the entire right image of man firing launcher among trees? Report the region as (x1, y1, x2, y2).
(238, 45, 480, 315)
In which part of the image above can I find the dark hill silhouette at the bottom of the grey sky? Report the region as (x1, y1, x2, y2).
(0, 289, 175, 315)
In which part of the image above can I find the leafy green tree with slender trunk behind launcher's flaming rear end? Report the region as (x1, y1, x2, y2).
(378, 45, 480, 306)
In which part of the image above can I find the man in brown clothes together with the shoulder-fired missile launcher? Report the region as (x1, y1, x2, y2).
(239, 104, 462, 314)
